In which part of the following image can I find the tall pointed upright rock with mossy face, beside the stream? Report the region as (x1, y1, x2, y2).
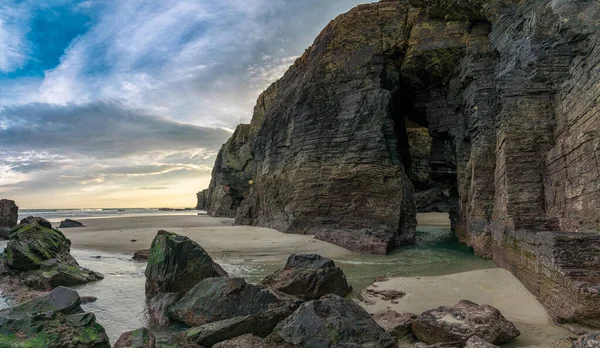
(145, 231, 227, 325)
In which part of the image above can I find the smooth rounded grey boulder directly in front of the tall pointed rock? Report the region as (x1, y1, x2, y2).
(169, 277, 281, 326)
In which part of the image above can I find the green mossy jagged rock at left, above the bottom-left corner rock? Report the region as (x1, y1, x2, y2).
(4, 217, 103, 290)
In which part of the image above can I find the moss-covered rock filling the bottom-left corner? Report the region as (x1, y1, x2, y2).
(0, 287, 110, 348)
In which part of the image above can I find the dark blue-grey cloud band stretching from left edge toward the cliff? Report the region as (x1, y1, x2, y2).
(0, 102, 231, 158)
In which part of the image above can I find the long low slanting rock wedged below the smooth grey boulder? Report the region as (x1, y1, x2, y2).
(180, 303, 296, 347)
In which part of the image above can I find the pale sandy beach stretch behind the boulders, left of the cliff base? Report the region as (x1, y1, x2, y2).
(62, 215, 352, 261)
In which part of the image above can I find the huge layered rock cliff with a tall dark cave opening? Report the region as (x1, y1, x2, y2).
(203, 0, 600, 327)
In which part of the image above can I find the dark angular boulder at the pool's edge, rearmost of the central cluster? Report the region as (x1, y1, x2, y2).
(261, 254, 352, 301)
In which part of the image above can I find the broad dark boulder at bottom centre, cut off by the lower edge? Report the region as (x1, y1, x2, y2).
(269, 295, 396, 348)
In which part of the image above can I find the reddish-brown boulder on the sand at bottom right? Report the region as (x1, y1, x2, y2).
(412, 300, 520, 344)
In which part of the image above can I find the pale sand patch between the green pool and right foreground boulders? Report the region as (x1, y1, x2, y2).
(359, 268, 573, 347)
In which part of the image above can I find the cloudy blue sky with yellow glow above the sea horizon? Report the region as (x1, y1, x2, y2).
(0, 0, 369, 209)
